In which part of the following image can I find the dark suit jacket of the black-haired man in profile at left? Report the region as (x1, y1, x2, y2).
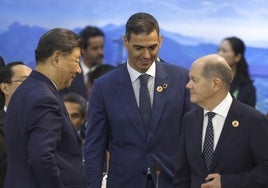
(5, 71, 86, 188)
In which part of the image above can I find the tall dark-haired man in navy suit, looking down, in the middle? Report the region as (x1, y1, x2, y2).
(84, 13, 192, 188)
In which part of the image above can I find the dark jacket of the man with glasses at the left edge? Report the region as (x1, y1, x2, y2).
(0, 110, 7, 188)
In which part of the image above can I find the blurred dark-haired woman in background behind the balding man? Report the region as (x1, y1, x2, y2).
(218, 37, 256, 107)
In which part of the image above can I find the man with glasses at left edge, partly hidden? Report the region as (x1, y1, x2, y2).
(0, 61, 32, 188)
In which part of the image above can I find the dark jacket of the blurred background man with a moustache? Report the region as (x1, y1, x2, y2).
(60, 73, 88, 99)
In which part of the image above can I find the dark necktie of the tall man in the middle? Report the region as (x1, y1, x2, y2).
(139, 74, 152, 131)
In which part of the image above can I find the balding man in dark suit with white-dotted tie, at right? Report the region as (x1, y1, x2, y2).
(175, 54, 268, 188)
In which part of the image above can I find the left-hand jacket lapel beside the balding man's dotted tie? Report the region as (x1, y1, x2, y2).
(193, 107, 207, 174)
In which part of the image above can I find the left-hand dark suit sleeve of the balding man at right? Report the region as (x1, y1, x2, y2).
(174, 118, 191, 188)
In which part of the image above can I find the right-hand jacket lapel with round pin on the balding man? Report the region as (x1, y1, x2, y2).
(211, 99, 242, 170)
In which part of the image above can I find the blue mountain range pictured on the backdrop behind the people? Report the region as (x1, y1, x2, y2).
(0, 22, 268, 113)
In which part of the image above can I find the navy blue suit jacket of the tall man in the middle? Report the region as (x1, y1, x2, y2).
(85, 62, 191, 188)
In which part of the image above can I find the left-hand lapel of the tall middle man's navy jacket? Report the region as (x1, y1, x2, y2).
(115, 63, 146, 140)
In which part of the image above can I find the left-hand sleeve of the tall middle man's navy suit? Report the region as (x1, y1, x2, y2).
(84, 80, 108, 188)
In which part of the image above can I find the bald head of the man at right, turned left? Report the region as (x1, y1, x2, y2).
(186, 54, 233, 110)
